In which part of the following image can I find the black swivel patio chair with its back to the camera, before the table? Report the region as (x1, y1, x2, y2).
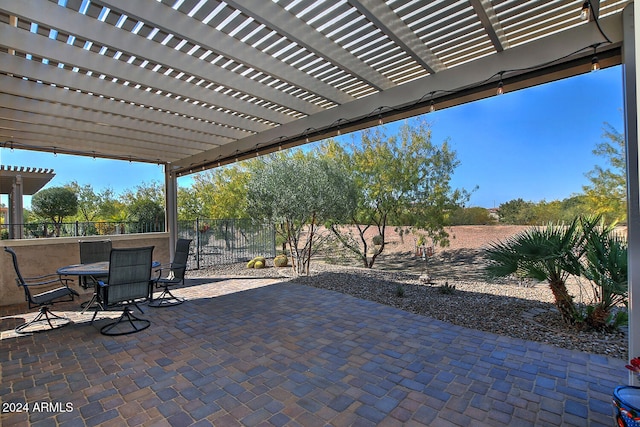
(91, 246, 153, 335)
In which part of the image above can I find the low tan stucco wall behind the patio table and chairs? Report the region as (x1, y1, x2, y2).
(0, 233, 170, 306)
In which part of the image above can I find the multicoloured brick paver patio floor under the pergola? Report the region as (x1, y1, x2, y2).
(0, 279, 627, 426)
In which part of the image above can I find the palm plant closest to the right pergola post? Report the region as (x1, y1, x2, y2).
(581, 217, 628, 329)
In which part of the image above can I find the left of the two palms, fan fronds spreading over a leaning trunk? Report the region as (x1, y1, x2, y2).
(486, 218, 582, 324)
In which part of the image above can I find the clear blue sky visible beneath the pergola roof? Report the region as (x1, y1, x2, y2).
(0, 67, 624, 208)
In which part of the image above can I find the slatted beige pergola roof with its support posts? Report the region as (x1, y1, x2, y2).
(0, 0, 640, 372)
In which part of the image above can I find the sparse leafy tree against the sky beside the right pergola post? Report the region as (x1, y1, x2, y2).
(583, 123, 627, 222)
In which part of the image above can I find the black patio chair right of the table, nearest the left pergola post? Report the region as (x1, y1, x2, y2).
(149, 239, 191, 307)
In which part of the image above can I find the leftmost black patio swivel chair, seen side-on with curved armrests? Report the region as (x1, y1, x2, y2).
(4, 246, 80, 334)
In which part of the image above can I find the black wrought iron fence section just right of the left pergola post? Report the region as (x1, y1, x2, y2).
(178, 219, 276, 269)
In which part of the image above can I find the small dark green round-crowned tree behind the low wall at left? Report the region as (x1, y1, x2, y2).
(31, 187, 78, 237)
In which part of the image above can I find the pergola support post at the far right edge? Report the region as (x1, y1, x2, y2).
(622, 3, 640, 385)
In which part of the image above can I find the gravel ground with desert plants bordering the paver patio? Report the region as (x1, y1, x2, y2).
(188, 249, 628, 360)
